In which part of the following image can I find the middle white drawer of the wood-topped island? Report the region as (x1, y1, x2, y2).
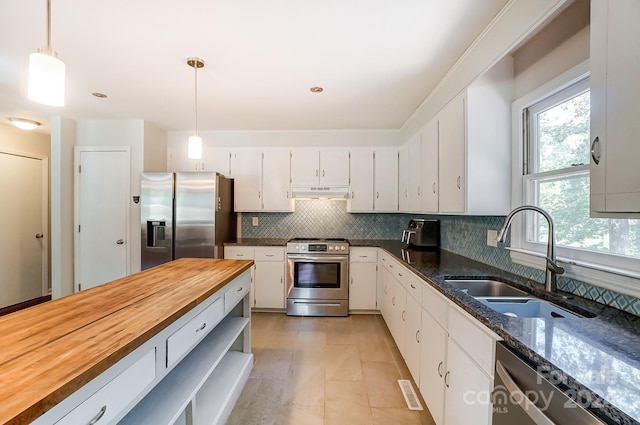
(167, 297, 224, 367)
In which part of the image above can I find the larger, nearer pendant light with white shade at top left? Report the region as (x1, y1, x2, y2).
(27, 0, 65, 106)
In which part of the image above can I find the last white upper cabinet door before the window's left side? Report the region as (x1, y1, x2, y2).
(438, 96, 465, 213)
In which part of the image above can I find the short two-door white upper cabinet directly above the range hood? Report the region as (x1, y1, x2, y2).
(291, 149, 349, 187)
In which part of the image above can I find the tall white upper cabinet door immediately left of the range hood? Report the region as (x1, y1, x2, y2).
(262, 149, 294, 212)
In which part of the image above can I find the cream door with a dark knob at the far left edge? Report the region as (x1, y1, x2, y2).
(0, 152, 49, 308)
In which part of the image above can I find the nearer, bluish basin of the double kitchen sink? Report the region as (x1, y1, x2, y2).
(476, 298, 584, 319)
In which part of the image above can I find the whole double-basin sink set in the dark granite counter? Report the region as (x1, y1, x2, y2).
(445, 278, 593, 318)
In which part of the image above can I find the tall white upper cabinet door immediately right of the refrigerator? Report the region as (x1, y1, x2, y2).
(231, 149, 262, 212)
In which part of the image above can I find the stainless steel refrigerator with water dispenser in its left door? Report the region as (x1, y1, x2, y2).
(140, 172, 237, 270)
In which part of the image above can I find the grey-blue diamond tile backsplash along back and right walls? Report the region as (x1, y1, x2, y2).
(242, 199, 640, 316)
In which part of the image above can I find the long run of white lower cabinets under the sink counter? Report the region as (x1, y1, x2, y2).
(379, 248, 500, 425)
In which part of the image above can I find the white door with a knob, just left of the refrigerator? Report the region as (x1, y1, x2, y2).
(75, 147, 129, 290)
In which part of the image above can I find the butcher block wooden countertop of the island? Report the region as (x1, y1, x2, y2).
(0, 258, 253, 424)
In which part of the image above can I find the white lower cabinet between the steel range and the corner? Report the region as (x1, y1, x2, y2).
(349, 248, 378, 310)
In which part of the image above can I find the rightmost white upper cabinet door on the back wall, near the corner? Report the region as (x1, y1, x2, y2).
(373, 149, 398, 212)
